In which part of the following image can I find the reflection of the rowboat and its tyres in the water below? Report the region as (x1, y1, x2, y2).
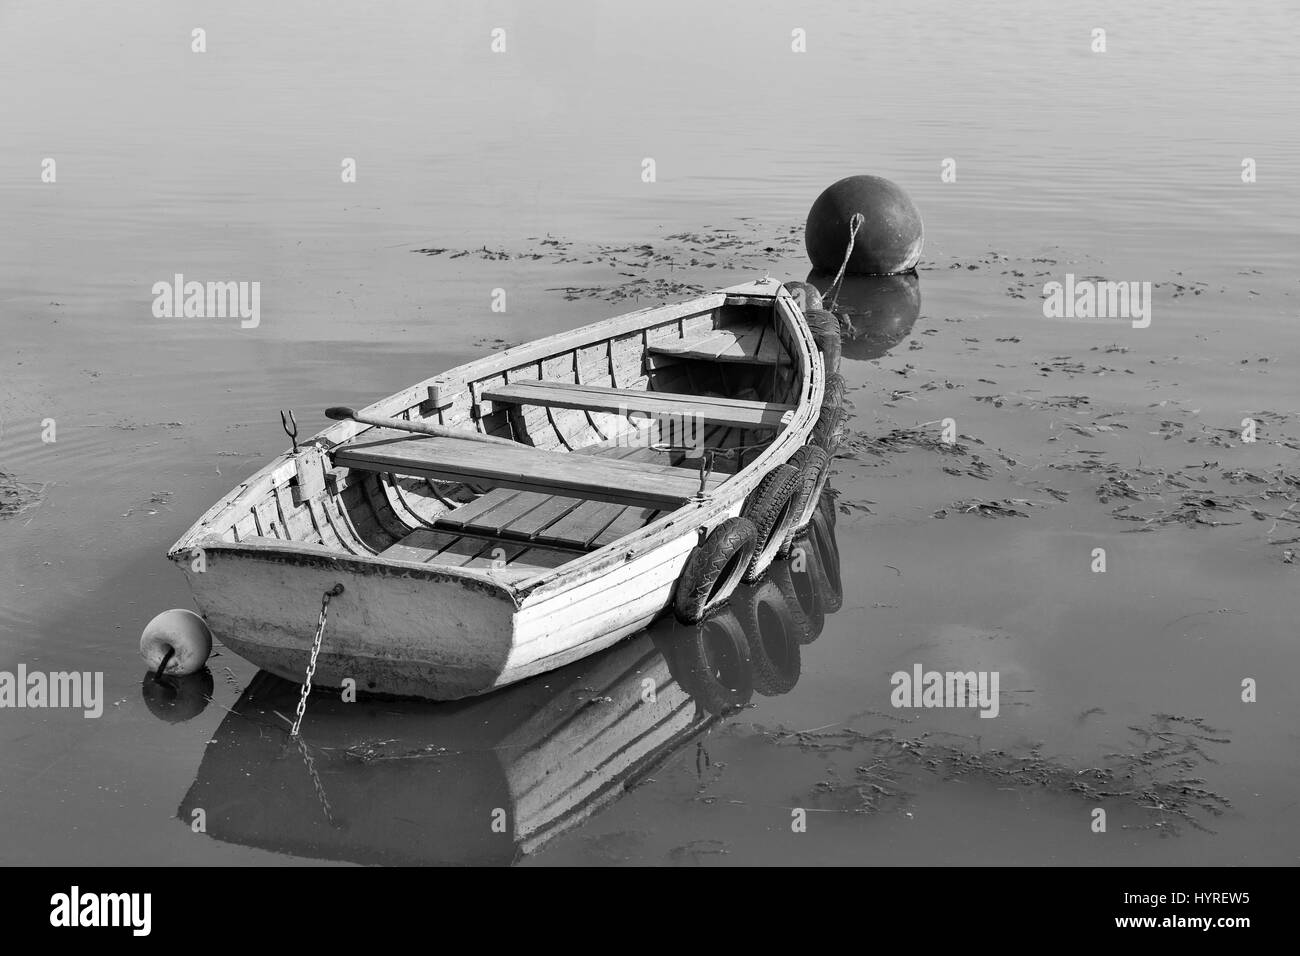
(178, 493, 841, 865)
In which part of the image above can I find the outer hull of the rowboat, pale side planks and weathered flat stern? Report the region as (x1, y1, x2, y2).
(180, 505, 740, 700)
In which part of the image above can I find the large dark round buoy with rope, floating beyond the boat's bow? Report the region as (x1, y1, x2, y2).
(803, 176, 924, 276)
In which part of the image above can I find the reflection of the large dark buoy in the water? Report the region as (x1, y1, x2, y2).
(807, 271, 920, 362)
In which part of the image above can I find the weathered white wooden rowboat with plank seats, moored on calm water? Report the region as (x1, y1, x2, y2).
(169, 278, 826, 698)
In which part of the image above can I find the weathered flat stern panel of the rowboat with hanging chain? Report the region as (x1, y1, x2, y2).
(170, 541, 517, 700)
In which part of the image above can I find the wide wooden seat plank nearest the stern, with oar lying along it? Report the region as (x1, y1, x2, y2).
(332, 429, 723, 507)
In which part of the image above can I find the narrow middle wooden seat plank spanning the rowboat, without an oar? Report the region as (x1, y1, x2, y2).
(482, 382, 794, 428)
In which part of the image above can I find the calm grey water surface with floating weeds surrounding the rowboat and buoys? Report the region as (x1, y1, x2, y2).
(0, 0, 1300, 865)
